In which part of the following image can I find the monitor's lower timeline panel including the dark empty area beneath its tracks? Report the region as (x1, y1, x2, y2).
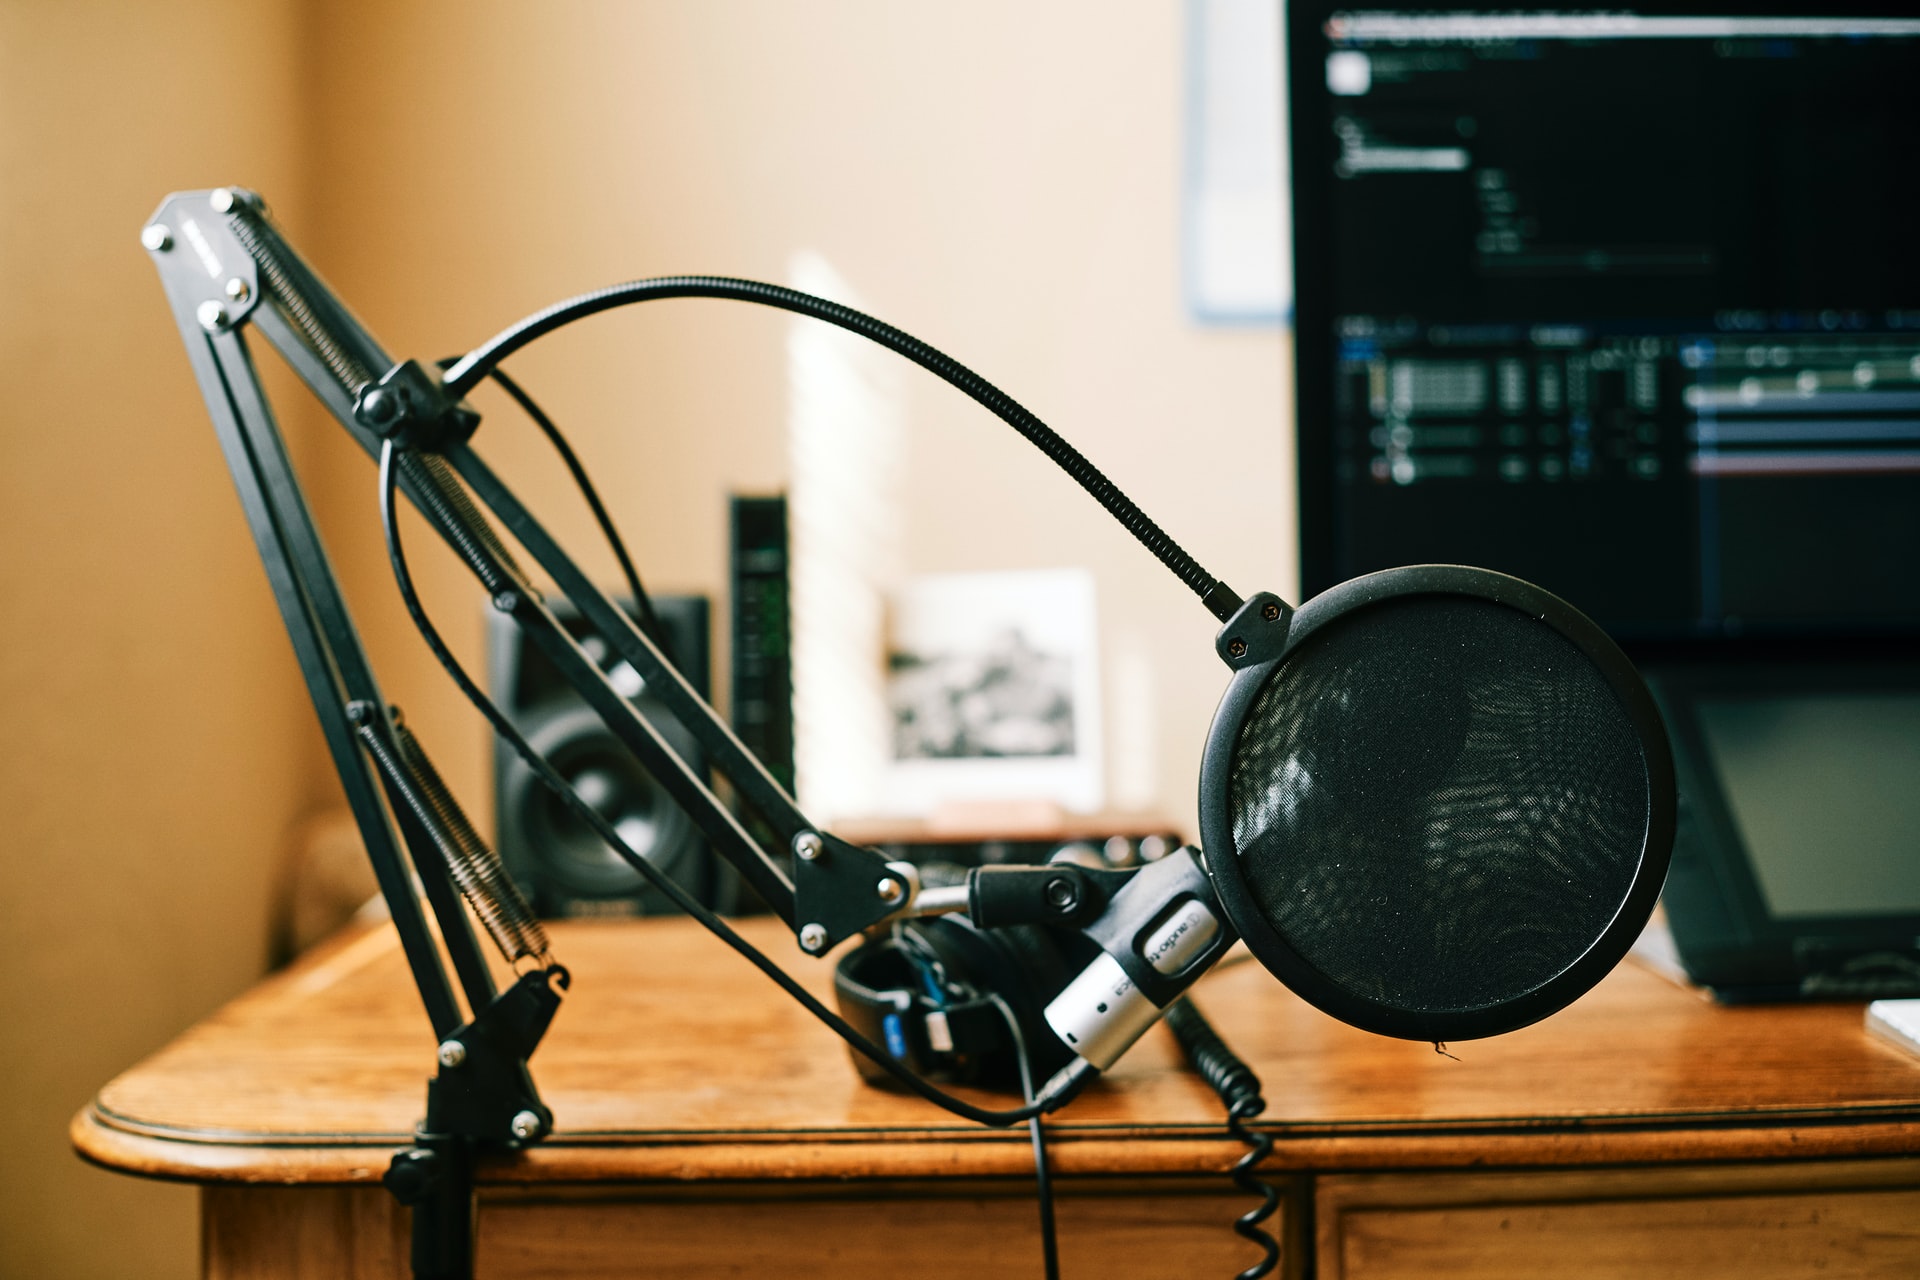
(1332, 317, 1920, 635)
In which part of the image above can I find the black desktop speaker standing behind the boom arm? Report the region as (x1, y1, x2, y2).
(488, 595, 735, 917)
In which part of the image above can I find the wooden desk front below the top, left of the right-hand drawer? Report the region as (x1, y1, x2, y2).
(204, 1184, 1296, 1280)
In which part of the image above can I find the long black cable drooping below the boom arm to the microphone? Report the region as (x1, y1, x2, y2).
(380, 439, 1092, 1128)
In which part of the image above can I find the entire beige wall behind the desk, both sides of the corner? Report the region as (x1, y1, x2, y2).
(0, 0, 1294, 1276)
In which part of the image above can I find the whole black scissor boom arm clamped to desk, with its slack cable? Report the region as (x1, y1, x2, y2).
(142, 188, 1104, 1278)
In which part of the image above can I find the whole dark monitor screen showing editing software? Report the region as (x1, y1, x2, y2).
(1288, 2, 1920, 641)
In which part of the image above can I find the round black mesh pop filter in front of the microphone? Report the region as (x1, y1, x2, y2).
(1200, 564, 1674, 1042)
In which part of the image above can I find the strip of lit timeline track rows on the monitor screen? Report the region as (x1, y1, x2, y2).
(1334, 326, 1920, 486)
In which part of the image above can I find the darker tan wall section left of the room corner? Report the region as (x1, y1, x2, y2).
(0, 0, 317, 1276)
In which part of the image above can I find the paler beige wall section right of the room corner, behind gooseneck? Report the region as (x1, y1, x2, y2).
(309, 0, 1294, 823)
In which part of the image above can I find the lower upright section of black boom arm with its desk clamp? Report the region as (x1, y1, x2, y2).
(142, 192, 566, 1278)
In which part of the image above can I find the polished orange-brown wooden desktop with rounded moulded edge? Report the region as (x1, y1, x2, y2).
(73, 919, 1920, 1184)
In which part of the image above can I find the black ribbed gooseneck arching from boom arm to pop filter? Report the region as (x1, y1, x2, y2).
(445, 276, 1240, 622)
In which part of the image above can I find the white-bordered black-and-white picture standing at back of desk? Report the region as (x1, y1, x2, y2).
(883, 570, 1104, 814)
